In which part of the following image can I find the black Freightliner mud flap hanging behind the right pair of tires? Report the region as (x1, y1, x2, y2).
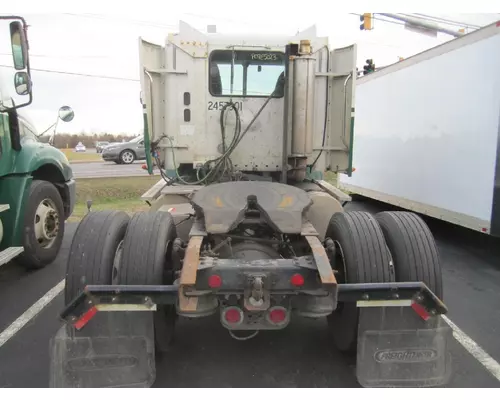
(356, 307, 452, 387)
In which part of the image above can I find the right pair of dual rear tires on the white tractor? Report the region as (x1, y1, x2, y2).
(326, 211, 443, 353)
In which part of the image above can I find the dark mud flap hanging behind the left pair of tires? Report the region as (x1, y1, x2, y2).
(50, 312, 156, 388)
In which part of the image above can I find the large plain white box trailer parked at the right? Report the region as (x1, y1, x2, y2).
(339, 21, 500, 236)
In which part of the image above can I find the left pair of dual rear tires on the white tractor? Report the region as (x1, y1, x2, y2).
(65, 210, 177, 352)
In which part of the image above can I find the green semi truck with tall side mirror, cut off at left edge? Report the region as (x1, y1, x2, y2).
(0, 16, 75, 268)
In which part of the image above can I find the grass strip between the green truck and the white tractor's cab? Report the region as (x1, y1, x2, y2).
(69, 176, 159, 222)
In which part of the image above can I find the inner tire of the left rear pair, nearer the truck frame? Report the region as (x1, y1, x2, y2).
(118, 212, 177, 352)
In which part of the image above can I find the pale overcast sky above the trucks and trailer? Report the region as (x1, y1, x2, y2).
(0, 5, 500, 134)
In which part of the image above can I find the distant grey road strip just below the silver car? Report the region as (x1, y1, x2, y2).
(71, 161, 148, 179)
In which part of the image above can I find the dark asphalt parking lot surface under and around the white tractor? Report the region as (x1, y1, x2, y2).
(0, 201, 500, 388)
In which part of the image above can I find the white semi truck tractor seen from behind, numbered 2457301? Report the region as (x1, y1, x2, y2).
(50, 22, 451, 387)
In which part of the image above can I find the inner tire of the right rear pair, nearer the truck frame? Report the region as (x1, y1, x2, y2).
(326, 211, 395, 353)
